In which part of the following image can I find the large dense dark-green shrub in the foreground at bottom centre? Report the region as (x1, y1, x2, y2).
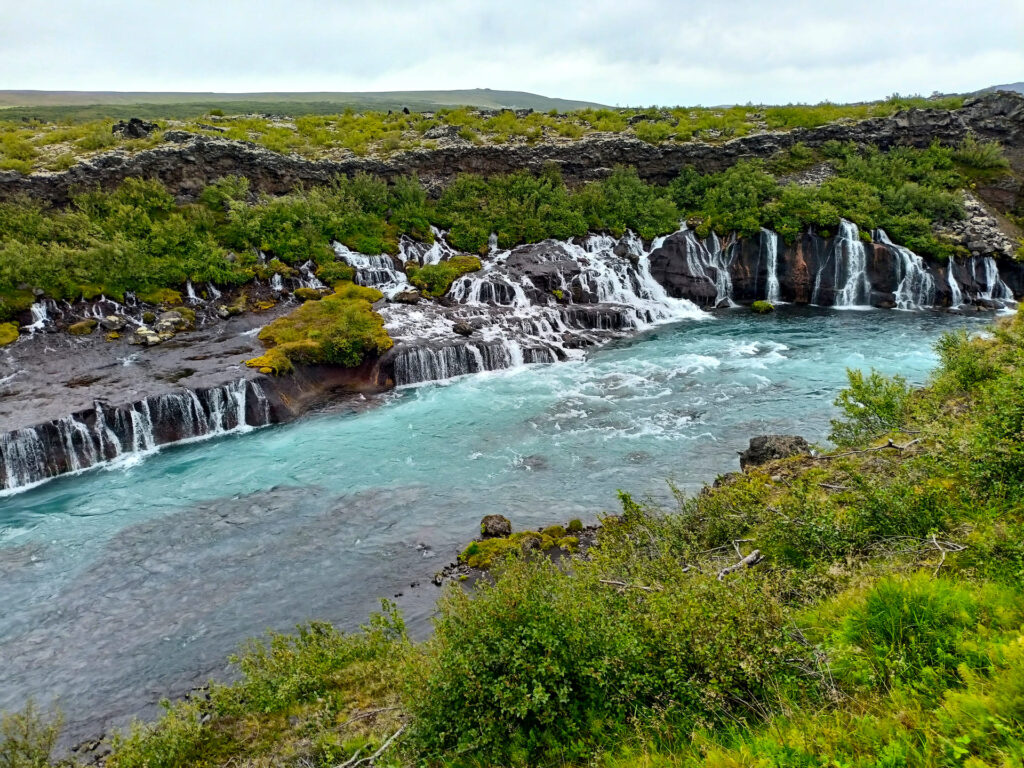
(409, 559, 791, 765)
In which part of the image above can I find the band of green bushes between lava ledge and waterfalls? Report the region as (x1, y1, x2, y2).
(0, 138, 1006, 321)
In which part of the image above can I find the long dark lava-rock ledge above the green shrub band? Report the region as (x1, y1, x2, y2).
(0, 92, 1024, 204)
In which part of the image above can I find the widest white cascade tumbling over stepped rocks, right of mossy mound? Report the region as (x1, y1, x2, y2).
(382, 227, 707, 386)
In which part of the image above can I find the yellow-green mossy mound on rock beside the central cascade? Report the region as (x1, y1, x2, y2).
(246, 283, 394, 374)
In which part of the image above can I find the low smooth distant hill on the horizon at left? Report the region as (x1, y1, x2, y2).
(0, 88, 603, 119)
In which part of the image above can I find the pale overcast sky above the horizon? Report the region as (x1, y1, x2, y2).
(0, 0, 1024, 105)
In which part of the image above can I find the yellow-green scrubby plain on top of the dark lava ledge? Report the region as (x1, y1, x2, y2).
(0, 95, 964, 173)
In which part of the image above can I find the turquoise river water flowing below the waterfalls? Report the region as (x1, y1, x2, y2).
(0, 309, 990, 738)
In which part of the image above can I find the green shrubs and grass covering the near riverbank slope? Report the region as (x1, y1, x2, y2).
(5, 314, 1024, 768)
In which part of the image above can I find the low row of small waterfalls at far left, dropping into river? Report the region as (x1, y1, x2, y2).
(0, 379, 271, 494)
